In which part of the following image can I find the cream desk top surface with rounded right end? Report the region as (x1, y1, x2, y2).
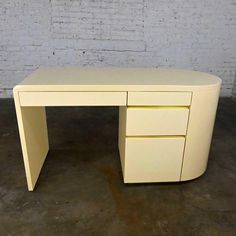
(14, 67, 221, 91)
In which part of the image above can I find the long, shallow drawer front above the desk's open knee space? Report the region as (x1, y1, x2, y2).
(19, 92, 127, 106)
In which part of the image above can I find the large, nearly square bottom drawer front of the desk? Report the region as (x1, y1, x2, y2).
(124, 137, 185, 183)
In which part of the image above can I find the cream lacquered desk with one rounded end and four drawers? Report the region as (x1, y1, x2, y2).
(14, 68, 221, 191)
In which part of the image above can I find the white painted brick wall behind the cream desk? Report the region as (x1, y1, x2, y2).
(0, 0, 236, 97)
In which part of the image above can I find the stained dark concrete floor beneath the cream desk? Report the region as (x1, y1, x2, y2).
(0, 99, 236, 236)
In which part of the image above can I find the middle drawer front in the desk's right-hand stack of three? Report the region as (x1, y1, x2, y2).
(126, 108, 189, 136)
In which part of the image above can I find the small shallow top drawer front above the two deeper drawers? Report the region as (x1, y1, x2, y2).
(128, 92, 192, 106)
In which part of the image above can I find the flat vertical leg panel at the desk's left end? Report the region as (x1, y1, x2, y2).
(14, 92, 49, 191)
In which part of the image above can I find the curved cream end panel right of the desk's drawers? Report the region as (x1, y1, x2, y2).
(181, 85, 220, 181)
